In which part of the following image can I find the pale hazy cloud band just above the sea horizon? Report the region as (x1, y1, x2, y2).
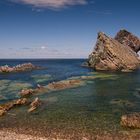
(0, 45, 89, 59)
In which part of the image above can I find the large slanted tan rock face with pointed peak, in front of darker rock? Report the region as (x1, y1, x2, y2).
(88, 32, 140, 71)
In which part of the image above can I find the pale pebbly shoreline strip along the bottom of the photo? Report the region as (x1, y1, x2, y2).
(0, 128, 140, 140)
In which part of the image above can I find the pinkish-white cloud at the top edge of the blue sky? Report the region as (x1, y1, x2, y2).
(10, 0, 87, 9)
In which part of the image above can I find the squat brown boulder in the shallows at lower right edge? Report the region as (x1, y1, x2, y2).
(120, 112, 140, 128)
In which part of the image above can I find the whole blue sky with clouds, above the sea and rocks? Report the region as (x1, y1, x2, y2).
(0, 0, 140, 58)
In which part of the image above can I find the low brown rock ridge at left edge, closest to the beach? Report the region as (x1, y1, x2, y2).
(0, 98, 27, 116)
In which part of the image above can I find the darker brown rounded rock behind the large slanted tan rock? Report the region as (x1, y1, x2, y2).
(115, 30, 140, 52)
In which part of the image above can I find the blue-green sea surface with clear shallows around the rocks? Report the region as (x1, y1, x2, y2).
(0, 59, 140, 137)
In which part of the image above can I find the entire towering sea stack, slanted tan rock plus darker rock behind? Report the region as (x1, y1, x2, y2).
(87, 30, 140, 71)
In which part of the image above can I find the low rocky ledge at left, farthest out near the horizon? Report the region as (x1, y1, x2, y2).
(0, 63, 39, 73)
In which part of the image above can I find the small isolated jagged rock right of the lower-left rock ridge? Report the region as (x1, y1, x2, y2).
(28, 97, 41, 112)
